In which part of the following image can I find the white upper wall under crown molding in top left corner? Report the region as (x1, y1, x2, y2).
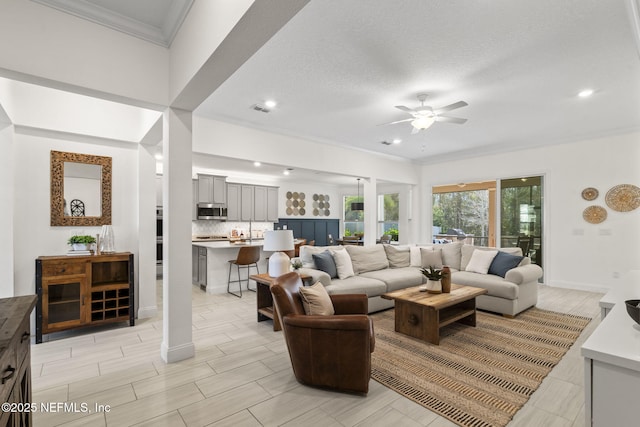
(0, 0, 169, 105)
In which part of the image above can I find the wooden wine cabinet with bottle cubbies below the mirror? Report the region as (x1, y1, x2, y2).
(36, 252, 135, 344)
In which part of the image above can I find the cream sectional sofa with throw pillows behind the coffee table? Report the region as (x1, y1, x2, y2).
(300, 242, 542, 316)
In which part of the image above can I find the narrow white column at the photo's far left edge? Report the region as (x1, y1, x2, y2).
(0, 123, 14, 298)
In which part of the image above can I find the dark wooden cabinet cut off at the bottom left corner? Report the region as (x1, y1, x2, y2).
(0, 295, 36, 426)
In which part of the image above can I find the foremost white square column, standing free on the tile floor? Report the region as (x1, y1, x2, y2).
(161, 108, 195, 363)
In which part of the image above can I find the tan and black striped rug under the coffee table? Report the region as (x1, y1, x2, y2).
(371, 308, 591, 427)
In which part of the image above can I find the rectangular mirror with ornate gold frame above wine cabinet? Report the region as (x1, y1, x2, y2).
(51, 151, 111, 227)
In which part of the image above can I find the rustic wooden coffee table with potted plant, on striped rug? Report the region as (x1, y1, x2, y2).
(382, 284, 487, 345)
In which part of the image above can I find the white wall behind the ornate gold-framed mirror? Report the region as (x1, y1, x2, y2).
(10, 133, 138, 295)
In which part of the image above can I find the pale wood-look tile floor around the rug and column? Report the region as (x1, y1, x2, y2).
(31, 283, 602, 427)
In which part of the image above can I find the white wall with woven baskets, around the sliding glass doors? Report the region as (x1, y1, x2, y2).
(421, 133, 640, 290)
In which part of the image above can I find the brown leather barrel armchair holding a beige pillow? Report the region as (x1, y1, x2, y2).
(271, 272, 375, 393)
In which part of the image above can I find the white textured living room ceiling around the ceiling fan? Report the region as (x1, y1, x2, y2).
(196, 0, 640, 162)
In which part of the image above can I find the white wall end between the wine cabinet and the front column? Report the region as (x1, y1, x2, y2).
(135, 144, 158, 319)
